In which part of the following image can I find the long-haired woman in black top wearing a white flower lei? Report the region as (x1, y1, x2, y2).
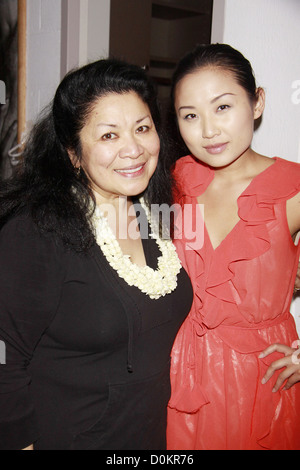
(0, 60, 192, 450)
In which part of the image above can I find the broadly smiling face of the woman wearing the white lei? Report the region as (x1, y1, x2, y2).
(72, 92, 160, 204)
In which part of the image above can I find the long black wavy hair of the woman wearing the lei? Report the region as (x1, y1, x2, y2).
(0, 59, 172, 252)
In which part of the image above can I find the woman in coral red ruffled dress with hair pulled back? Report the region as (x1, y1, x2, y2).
(168, 44, 300, 449)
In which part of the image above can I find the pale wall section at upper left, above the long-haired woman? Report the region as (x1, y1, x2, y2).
(26, 0, 110, 129)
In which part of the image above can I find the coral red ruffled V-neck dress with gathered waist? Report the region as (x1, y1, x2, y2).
(167, 156, 300, 450)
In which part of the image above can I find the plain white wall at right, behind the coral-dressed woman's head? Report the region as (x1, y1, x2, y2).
(212, 0, 300, 332)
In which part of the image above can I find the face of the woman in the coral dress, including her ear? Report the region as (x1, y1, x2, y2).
(175, 67, 264, 168)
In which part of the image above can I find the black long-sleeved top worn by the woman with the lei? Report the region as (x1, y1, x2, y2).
(0, 211, 192, 450)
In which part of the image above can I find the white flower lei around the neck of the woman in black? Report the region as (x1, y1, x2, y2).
(93, 198, 181, 299)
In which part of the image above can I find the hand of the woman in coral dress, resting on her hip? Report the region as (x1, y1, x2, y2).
(259, 341, 300, 392)
